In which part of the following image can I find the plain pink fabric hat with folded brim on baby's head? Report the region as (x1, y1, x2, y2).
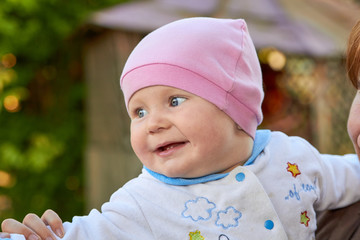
(120, 17, 264, 138)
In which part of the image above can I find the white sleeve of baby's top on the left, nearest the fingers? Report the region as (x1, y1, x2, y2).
(58, 189, 153, 240)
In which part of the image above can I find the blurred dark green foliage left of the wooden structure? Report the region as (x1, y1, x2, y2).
(0, 0, 129, 221)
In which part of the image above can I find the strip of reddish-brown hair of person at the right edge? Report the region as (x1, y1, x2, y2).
(346, 21, 360, 88)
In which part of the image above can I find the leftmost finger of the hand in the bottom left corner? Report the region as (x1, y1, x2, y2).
(1, 218, 40, 240)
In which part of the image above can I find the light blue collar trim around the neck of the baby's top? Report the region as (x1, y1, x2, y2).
(144, 130, 271, 186)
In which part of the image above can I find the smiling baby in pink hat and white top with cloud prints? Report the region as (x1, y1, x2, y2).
(3, 18, 360, 240)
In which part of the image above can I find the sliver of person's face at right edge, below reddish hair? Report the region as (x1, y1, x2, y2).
(348, 90, 360, 159)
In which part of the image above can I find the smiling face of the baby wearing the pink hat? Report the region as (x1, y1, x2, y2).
(129, 86, 253, 178)
